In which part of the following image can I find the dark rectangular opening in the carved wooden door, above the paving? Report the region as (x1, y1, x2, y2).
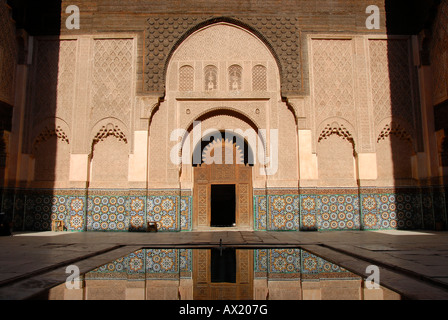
(210, 184, 236, 227)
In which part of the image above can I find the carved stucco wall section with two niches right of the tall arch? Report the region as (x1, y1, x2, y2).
(308, 35, 421, 184)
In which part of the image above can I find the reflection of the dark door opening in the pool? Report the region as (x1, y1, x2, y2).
(211, 248, 236, 283)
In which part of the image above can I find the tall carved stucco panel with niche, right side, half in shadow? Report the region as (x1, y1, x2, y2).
(369, 39, 422, 185)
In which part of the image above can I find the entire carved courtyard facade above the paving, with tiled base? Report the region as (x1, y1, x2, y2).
(0, 0, 448, 232)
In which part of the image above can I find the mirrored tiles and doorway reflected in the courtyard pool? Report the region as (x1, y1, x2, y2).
(44, 248, 400, 300)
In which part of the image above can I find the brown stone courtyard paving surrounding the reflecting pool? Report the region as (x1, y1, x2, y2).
(0, 230, 448, 300)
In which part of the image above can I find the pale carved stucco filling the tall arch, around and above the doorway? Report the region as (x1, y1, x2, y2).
(158, 22, 298, 189)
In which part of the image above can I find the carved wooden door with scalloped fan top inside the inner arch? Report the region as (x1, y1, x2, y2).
(193, 132, 253, 230)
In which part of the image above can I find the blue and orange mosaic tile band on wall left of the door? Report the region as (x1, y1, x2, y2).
(2, 190, 192, 231)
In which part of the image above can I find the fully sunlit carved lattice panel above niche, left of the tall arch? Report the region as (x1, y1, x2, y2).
(91, 39, 133, 123)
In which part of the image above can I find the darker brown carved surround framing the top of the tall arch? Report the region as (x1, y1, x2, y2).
(145, 15, 303, 95)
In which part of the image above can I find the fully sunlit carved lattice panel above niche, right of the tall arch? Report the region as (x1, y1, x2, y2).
(312, 39, 355, 123)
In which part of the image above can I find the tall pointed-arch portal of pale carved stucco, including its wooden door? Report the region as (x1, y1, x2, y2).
(161, 22, 286, 230)
